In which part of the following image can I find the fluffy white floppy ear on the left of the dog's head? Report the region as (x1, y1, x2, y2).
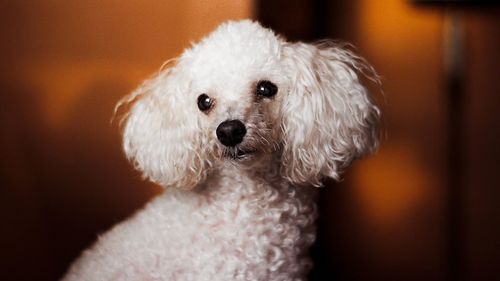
(117, 63, 211, 189)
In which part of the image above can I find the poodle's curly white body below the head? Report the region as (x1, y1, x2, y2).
(67, 159, 316, 281)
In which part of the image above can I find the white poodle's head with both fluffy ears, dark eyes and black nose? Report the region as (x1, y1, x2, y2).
(122, 21, 380, 189)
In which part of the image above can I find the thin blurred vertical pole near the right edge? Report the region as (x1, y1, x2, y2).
(444, 9, 466, 281)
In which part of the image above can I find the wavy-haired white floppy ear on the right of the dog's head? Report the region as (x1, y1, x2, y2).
(281, 42, 380, 186)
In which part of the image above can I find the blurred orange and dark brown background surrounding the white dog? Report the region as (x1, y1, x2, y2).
(0, 0, 500, 280)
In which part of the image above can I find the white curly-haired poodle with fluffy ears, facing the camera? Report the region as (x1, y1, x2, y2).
(63, 20, 380, 281)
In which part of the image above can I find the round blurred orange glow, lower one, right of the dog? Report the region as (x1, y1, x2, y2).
(353, 144, 433, 227)
